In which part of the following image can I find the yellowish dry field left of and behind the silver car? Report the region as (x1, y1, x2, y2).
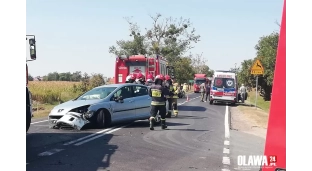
(28, 81, 81, 104)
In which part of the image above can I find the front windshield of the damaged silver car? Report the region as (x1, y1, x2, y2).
(76, 87, 116, 100)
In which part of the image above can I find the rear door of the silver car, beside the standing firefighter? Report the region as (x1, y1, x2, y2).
(133, 85, 151, 119)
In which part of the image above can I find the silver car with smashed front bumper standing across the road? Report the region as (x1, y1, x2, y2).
(49, 83, 151, 130)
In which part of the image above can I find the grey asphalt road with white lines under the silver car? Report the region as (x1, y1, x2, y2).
(25, 94, 264, 171)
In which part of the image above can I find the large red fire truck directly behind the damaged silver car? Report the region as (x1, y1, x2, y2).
(114, 55, 168, 84)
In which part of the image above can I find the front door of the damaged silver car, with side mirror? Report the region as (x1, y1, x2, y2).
(111, 86, 135, 122)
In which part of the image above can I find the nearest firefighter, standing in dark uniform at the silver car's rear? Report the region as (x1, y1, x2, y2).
(148, 74, 170, 130)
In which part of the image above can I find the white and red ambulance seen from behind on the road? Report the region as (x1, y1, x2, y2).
(209, 70, 238, 105)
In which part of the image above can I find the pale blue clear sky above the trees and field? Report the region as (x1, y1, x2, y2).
(24, 0, 283, 77)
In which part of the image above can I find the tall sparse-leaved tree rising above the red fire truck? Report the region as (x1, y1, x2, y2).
(109, 14, 204, 83)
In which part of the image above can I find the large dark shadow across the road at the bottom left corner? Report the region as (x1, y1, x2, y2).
(25, 130, 118, 171)
